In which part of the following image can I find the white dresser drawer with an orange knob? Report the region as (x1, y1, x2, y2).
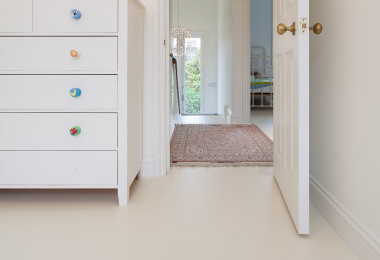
(0, 37, 117, 71)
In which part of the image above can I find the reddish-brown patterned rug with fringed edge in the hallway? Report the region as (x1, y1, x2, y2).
(170, 125, 273, 167)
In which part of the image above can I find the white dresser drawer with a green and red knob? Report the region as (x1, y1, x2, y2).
(0, 113, 117, 150)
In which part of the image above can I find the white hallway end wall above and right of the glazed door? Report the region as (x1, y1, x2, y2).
(170, 0, 218, 114)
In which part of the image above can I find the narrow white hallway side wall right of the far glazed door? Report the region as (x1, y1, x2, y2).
(218, 0, 232, 115)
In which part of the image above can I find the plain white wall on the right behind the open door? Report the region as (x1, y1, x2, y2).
(310, 0, 380, 259)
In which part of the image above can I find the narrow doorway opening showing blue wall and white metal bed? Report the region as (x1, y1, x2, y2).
(249, 0, 275, 140)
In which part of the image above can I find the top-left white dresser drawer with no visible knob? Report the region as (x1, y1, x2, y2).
(0, 0, 33, 33)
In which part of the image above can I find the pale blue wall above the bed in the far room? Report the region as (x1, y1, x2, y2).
(251, 0, 273, 55)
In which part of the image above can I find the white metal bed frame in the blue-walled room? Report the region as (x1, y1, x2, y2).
(249, 47, 273, 107)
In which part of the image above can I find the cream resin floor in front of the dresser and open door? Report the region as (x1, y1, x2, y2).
(0, 168, 356, 260)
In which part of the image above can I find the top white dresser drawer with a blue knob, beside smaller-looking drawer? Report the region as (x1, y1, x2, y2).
(34, 0, 118, 33)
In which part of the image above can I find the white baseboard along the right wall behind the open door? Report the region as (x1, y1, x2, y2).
(310, 176, 380, 260)
